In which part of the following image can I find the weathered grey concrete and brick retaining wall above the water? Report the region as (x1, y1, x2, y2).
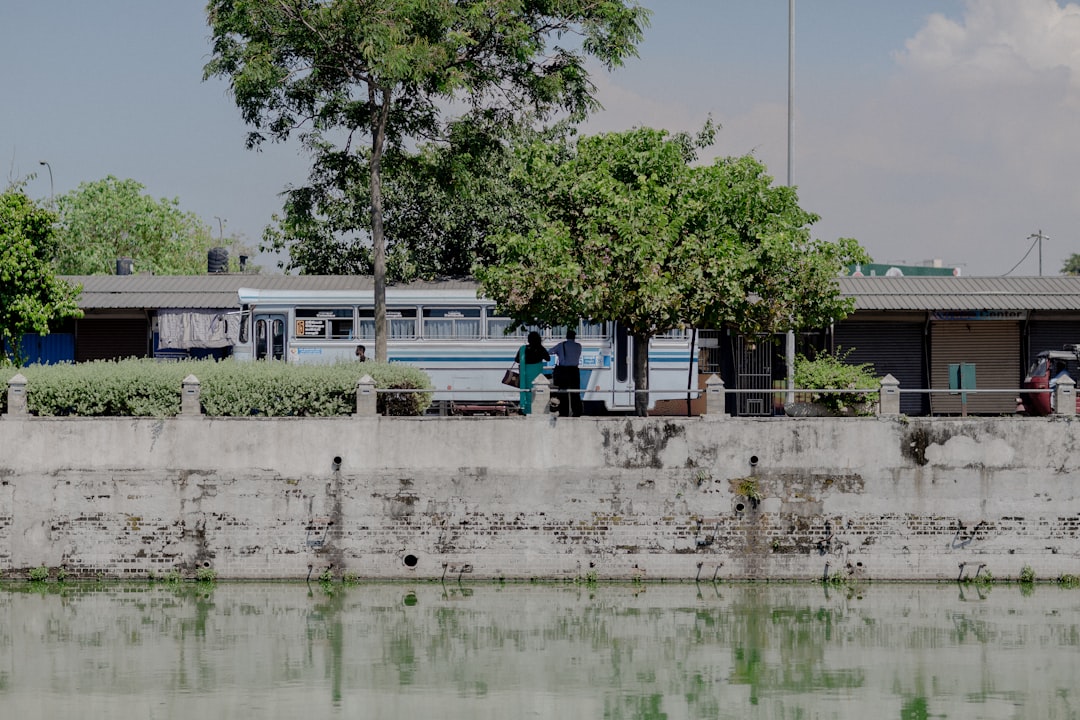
(0, 416, 1080, 580)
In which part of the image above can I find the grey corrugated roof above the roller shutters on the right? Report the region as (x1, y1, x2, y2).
(840, 276, 1080, 311)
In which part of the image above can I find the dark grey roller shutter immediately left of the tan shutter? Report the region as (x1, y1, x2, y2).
(833, 322, 930, 416)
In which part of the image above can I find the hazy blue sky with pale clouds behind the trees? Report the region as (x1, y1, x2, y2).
(0, 0, 1080, 276)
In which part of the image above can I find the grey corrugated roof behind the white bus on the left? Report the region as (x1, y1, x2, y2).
(63, 273, 476, 310)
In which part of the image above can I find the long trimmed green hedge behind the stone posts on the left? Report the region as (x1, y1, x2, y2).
(0, 359, 431, 418)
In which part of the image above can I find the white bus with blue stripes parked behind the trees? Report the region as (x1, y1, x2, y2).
(233, 281, 698, 413)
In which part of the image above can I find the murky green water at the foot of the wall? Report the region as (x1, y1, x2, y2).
(0, 583, 1080, 720)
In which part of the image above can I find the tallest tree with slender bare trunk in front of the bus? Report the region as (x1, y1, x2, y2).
(205, 0, 648, 361)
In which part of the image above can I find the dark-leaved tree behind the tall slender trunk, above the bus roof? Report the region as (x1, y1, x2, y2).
(264, 113, 561, 282)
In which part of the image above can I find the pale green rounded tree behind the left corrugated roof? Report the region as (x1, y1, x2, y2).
(55, 175, 219, 275)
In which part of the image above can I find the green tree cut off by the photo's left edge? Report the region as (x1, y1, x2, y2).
(0, 184, 82, 365)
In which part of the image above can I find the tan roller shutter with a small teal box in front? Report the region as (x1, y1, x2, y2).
(930, 321, 1023, 415)
